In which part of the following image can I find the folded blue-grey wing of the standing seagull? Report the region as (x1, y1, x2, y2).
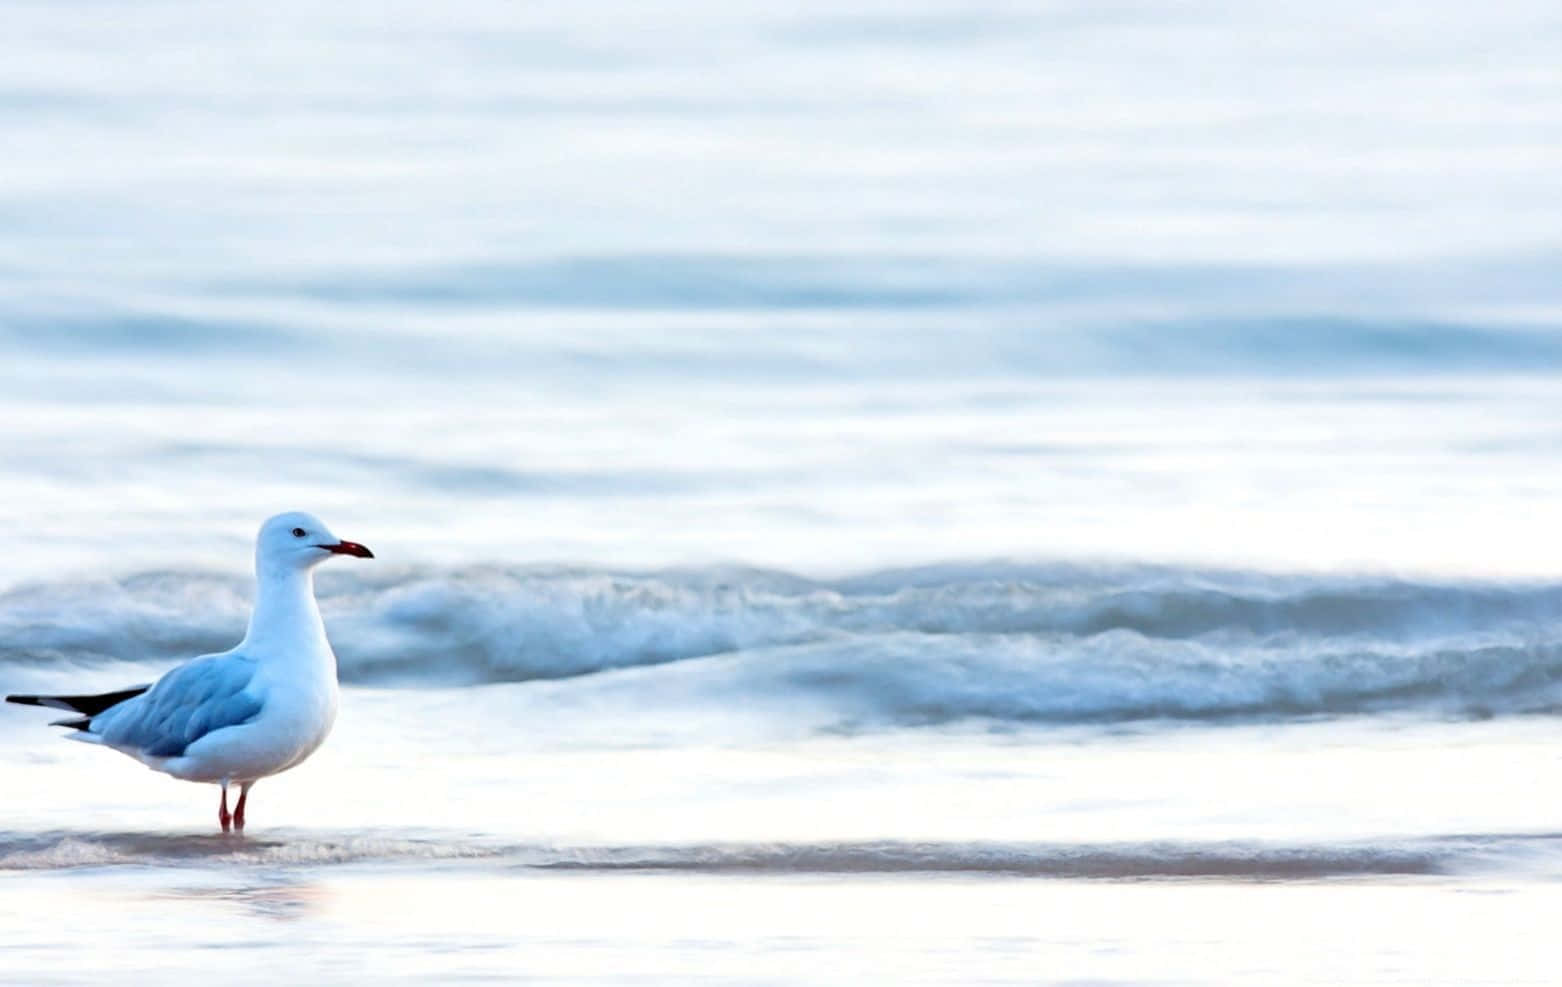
(91, 654, 264, 757)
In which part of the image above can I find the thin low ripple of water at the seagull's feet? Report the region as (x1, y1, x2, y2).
(0, 831, 1562, 881)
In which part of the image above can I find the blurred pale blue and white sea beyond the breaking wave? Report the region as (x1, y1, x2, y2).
(0, 2, 1562, 578)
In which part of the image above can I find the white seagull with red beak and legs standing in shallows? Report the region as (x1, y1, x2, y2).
(6, 512, 375, 832)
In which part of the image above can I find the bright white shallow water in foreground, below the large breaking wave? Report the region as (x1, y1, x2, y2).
(9, 712, 1562, 984)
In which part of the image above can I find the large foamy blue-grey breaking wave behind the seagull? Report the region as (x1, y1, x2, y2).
(0, 564, 1562, 725)
